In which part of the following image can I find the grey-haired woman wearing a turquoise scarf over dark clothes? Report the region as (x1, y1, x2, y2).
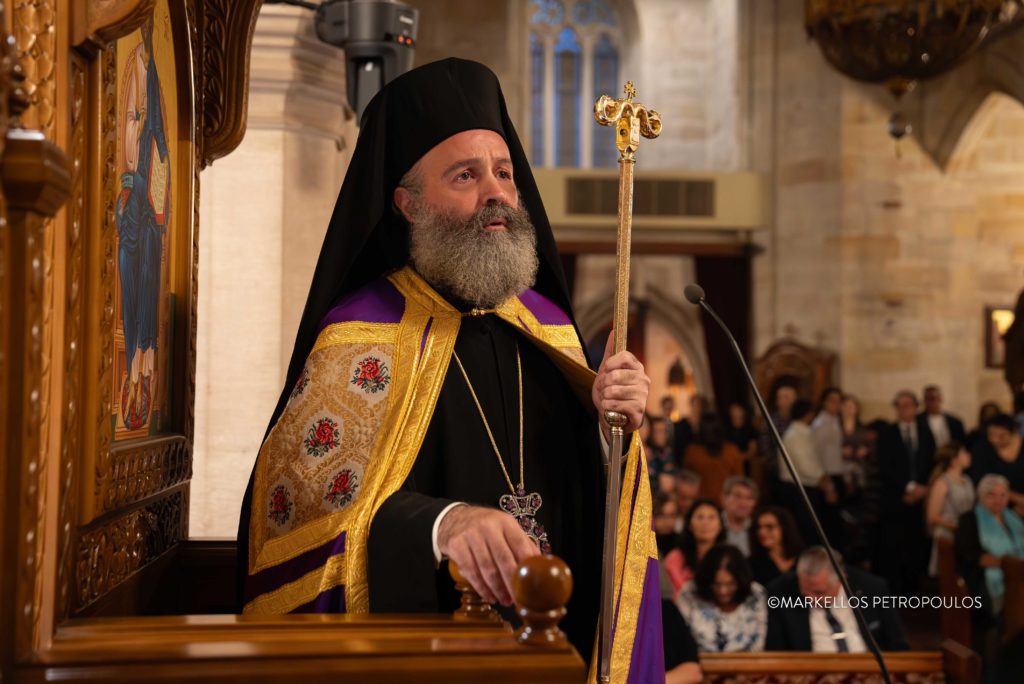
(953, 474, 1024, 617)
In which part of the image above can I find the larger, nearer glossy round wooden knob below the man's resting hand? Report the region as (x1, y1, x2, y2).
(512, 556, 572, 647)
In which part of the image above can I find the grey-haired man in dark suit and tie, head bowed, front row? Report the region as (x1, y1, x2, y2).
(765, 546, 909, 653)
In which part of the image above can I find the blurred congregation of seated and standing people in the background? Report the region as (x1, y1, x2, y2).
(642, 382, 1024, 682)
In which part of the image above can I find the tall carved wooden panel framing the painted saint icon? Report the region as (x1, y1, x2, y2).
(73, 0, 199, 614)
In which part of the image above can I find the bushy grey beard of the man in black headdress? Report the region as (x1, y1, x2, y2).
(409, 197, 538, 308)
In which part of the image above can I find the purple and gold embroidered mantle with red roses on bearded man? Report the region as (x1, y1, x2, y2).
(245, 267, 664, 682)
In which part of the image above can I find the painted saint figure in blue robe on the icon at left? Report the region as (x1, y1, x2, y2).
(116, 17, 170, 429)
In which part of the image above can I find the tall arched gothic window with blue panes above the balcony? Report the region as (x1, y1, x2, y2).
(528, 0, 623, 167)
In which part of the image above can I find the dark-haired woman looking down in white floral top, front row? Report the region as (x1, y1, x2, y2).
(676, 544, 768, 652)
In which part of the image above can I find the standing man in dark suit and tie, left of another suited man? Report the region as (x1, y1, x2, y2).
(874, 390, 935, 596)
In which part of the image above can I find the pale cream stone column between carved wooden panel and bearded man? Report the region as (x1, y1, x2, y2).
(190, 5, 356, 537)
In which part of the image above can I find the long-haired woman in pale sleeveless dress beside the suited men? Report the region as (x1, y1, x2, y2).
(925, 441, 975, 578)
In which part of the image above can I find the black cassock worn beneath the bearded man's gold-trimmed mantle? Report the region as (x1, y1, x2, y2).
(368, 314, 604, 660)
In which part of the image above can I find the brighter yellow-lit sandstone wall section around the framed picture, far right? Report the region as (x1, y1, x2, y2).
(840, 89, 1024, 423)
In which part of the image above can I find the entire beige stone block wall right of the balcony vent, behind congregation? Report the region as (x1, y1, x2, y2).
(744, 0, 1024, 424)
